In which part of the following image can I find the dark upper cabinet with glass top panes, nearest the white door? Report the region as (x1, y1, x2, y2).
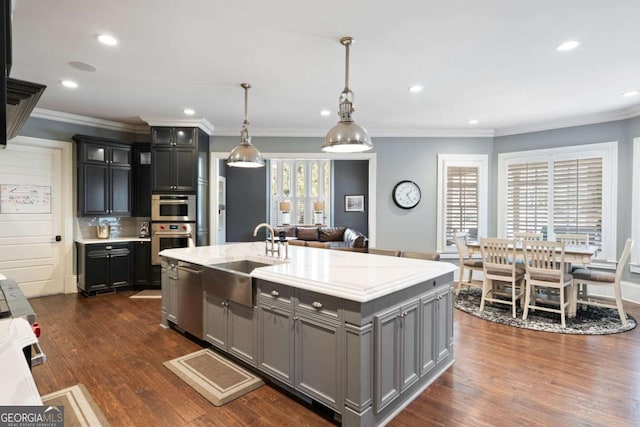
(73, 135, 132, 216)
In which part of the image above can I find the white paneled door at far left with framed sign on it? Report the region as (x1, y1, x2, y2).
(0, 137, 67, 297)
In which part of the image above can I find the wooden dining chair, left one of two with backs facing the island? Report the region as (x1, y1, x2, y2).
(480, 237, 524, 317)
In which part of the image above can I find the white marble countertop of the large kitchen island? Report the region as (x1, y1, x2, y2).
(160, 242, 457, 302)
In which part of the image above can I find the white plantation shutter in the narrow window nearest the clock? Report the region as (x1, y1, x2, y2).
(445, 166, 480, 246)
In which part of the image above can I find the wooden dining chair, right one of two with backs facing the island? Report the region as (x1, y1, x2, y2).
(522, 241, 574, 328)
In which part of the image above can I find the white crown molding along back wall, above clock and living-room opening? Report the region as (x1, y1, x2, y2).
(210, 128, 494, 138)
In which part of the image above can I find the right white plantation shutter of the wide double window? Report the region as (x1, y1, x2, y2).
(553, 157, 602, 246)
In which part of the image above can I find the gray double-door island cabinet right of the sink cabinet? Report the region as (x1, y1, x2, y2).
(257, 290, 343, 411)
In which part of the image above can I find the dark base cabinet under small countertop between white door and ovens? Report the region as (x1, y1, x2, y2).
(77, 242, 131, 295)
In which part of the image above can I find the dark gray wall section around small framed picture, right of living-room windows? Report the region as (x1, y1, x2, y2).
(333, 160, 369, 236)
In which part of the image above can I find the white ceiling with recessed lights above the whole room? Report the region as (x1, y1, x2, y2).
(11, 0, 640, 137)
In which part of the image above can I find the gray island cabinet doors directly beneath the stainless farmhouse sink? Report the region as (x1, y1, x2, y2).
(204, 292, 258, 366)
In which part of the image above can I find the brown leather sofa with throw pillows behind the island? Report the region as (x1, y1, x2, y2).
(274, 225, 369, 252)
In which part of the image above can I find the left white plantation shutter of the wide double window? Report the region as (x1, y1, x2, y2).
(506, 162, 549, 237)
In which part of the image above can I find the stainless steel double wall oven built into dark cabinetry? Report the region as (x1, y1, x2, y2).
(151, 194, 196, 265)
